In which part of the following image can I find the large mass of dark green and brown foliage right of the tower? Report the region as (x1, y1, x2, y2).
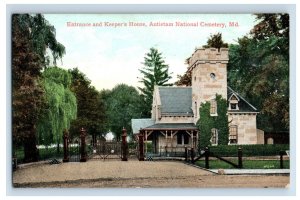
(228, 14, 289, 131)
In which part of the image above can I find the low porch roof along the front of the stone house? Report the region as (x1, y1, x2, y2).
(143, 123, 198, 131)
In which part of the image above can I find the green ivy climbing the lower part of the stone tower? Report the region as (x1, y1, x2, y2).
(197, 95, 229, 149)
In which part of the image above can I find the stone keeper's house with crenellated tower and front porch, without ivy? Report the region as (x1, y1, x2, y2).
(132, 48, 264, 153)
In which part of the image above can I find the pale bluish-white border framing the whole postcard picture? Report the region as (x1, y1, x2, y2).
(0, 0, 299, 198)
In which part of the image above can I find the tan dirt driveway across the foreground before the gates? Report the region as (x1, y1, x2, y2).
(13, 161, 289, 188)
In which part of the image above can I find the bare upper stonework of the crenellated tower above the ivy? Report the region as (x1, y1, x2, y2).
(188, 48, 229, 123)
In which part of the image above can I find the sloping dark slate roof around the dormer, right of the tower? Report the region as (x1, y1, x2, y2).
(227, 86, 259, 113)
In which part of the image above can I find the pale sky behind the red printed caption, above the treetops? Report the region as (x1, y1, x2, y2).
(44, 14, 255, 90)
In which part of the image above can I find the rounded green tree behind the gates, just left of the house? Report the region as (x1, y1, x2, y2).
(103, 84, 142, 140)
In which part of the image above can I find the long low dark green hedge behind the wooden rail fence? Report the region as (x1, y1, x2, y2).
(209, 144, 290, 157)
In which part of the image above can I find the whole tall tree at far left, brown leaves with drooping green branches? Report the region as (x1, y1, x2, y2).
(12, 14, 64, 162)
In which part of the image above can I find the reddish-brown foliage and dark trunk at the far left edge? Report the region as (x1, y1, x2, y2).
(12, 15, 43, 162)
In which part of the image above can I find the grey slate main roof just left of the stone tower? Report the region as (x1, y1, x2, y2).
(158, 87, 193, 116)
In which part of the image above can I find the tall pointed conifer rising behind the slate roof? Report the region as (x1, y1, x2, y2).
(139, 48, 172, 117)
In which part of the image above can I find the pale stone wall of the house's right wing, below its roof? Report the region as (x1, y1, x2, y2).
(228, 113, 258, 144)
